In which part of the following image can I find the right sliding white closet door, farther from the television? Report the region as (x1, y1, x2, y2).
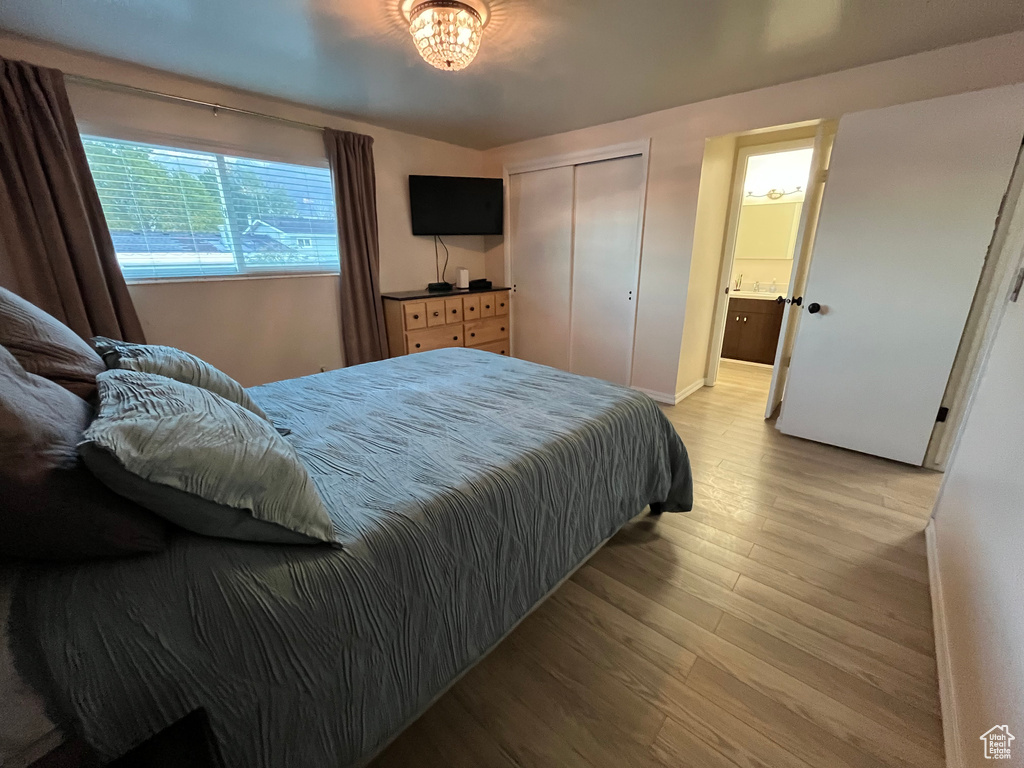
(569, 155, 644, 386)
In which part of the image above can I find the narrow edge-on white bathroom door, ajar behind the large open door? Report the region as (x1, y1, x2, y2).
(765, 123, 836, 419)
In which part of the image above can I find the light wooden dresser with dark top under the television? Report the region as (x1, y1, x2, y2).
(383, 288, 511, 357)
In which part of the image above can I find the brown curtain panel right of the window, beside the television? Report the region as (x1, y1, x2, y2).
(324, 128, 387, 366)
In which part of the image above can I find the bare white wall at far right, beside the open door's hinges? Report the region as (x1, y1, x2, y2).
(931, 264, 1024, 768)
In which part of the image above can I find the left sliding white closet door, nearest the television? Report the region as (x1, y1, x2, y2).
(509, 166, 573, 371)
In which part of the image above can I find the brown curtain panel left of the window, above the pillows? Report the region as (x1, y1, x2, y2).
(0, 57, 144, 342)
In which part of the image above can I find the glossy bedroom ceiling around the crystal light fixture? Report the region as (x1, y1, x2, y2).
(0, 0, 1024, 148)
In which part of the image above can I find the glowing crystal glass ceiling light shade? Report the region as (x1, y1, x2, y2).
(409, 0, 483, 72)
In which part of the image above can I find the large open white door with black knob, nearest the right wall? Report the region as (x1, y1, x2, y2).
(778, 86, 1024, 464)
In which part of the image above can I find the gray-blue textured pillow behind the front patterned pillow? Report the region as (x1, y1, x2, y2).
(92, 336, 269, 421)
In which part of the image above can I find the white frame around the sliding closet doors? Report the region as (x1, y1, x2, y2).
(502, 137, 650, 385)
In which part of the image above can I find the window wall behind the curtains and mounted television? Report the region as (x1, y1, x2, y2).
(0, 33, 484, 385)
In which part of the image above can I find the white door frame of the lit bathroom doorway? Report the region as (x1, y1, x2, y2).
(705, 135, 817, 387)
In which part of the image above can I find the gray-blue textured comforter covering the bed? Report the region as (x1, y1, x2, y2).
(11, 349, 692, 768)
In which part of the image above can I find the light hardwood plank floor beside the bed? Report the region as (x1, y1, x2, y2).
(374, 362, 944, 768)
